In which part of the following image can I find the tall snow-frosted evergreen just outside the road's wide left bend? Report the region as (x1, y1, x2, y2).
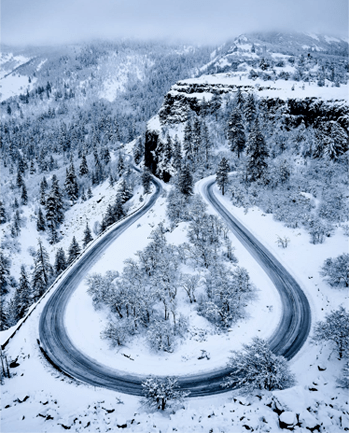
(32, 239, 52, 302)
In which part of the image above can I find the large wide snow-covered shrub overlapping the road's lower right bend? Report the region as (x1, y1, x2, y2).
(222, 337, 295, 392)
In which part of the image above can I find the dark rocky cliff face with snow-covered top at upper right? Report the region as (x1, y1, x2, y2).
(145, 74, 349, 181)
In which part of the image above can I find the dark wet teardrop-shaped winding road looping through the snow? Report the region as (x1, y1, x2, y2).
(39, 175, 311, 397)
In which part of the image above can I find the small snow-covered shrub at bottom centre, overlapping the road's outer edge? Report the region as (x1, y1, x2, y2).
(142, 377, 189, 410)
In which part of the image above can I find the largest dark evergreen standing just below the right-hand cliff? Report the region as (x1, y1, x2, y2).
(246, 120, 269, 182)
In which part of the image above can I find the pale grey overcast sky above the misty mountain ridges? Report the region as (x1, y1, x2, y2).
(1, 0, 348, 45)
